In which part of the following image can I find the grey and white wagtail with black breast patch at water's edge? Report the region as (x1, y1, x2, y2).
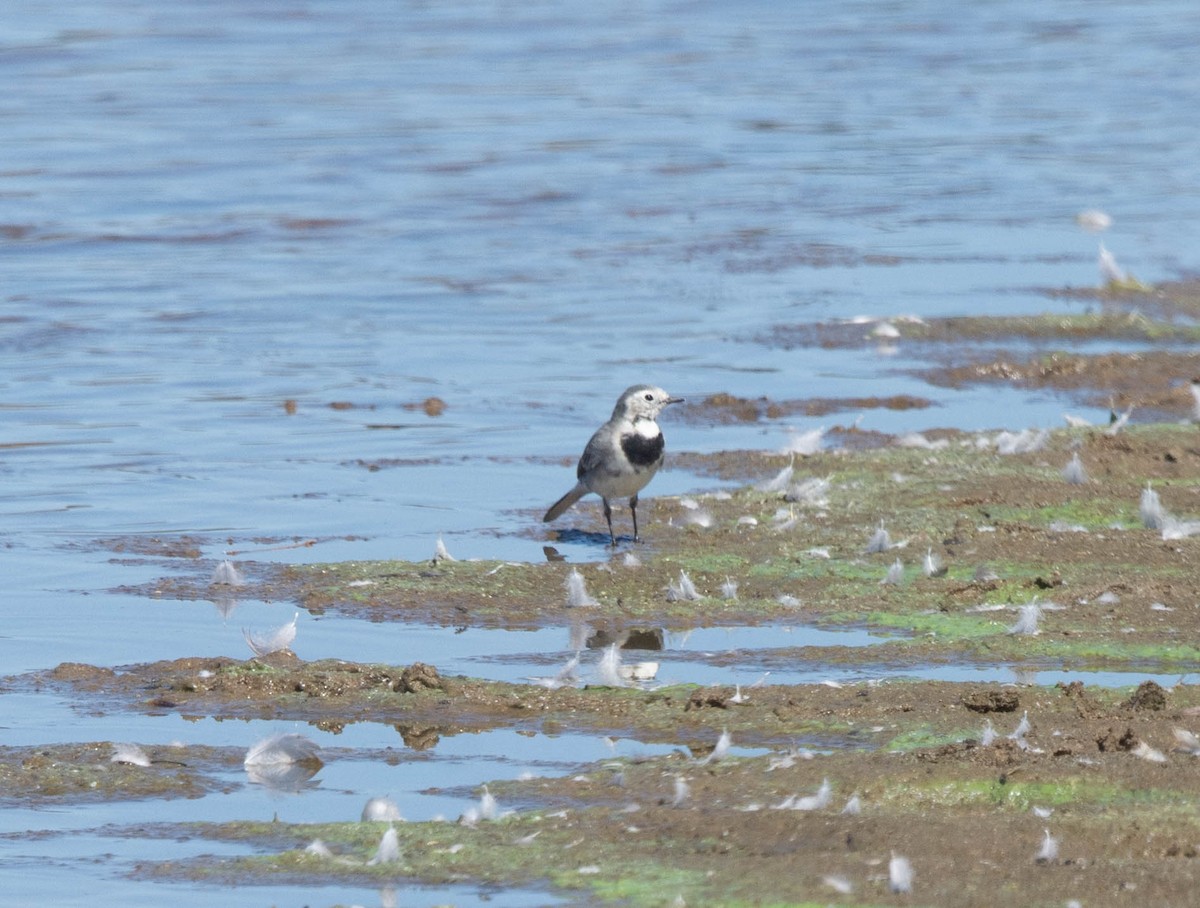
(542, 385, 683, 546)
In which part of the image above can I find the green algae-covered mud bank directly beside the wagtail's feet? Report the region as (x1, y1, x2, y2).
(265, 425, 1200, 666)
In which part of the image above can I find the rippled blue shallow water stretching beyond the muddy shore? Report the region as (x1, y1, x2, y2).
(0, 0, 1200, 904)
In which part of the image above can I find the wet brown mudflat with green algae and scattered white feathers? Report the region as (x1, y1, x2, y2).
(18, 285, 1200, 906)
